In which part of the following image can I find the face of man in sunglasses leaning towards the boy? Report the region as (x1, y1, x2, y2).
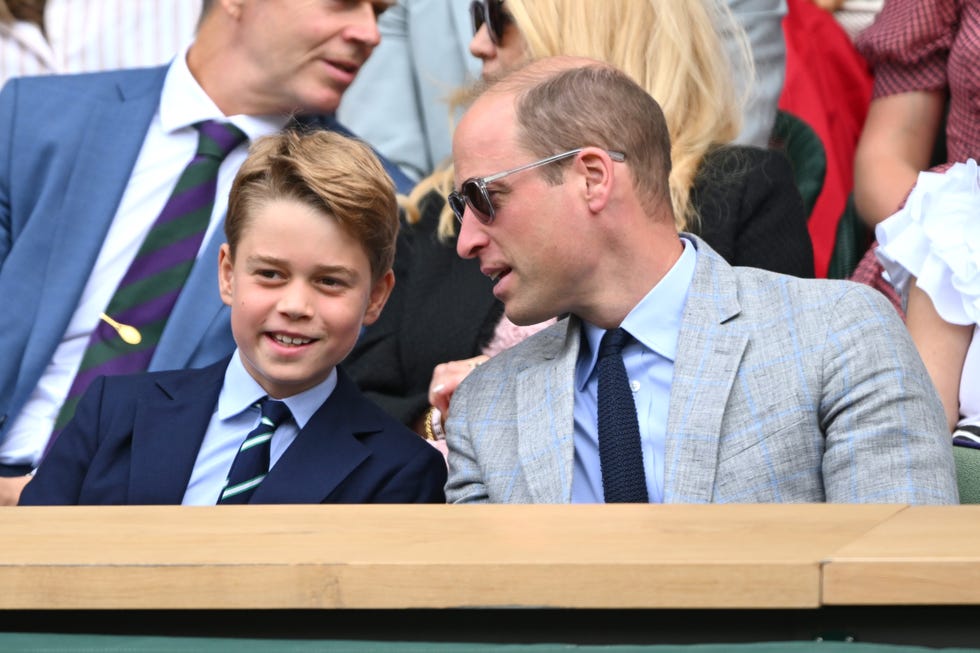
(453, 95, 594, 325)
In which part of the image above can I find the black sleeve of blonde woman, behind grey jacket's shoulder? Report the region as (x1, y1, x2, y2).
(691, 147, 814, 278)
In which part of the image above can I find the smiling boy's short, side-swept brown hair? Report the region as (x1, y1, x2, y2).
(225, 130, 398, 281)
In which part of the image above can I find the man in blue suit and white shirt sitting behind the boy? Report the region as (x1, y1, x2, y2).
(0, 0, 408, 502)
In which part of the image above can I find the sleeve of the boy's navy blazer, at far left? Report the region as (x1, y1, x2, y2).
(20, 377, 105, 506)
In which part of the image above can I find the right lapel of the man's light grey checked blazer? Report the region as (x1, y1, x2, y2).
(664, 237, 748, 503)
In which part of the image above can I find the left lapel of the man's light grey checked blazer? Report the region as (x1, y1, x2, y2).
(517, 318, 580, 503)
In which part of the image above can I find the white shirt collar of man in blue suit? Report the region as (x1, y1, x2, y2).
(160, 48, 289, 141)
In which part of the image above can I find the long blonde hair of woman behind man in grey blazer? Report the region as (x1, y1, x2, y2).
(409, 0, 754, 237)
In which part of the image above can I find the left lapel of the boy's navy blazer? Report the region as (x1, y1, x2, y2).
(129, 358, 228, 505)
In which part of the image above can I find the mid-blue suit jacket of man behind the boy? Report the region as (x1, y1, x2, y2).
(0, 66, 411, 440)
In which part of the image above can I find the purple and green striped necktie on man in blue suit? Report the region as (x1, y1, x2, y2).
(45, 120, 247, 452)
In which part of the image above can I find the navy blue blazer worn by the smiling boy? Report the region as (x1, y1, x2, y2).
(20, 359, 446, 505)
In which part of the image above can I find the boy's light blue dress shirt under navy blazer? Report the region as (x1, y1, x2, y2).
(181, 349, 337, 506)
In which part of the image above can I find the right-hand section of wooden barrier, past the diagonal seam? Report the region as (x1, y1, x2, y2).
(823, 505, 980, 605)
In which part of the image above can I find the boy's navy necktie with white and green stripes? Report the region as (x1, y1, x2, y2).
(218, 397, 290, 505)
